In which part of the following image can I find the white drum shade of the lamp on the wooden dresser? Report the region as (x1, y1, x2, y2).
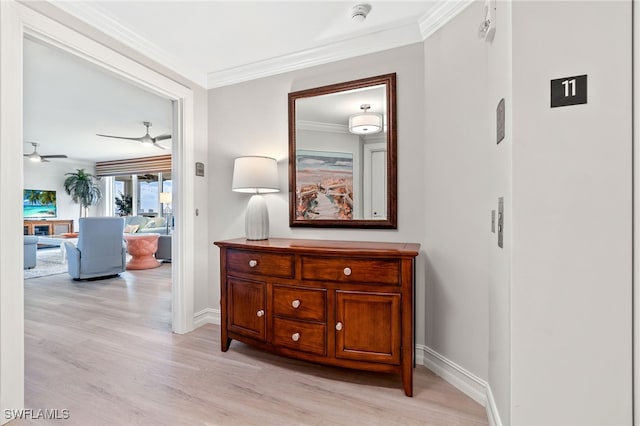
(231, 156, 280, 194)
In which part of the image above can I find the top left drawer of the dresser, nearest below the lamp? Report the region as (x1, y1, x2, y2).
(227, 250, 293, 278)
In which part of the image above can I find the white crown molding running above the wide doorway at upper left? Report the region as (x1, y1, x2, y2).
(50, 1, 207, 87)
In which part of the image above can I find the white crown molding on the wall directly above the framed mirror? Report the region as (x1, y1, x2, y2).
(207, 23, 422, 89)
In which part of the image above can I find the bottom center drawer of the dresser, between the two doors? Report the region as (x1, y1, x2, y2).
(272, 318, 327, 355)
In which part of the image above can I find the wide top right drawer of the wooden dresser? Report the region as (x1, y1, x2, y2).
(302, 256, 401, 285)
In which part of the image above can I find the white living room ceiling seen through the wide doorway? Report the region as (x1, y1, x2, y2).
(23, 39, 172, 162)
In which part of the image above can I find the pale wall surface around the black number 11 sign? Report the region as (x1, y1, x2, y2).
(511, 1, 632, 425)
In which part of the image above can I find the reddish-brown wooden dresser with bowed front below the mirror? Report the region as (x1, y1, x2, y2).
(214, 238, 420, 396)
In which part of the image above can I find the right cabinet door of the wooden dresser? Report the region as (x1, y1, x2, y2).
(335, 290, 401, 364)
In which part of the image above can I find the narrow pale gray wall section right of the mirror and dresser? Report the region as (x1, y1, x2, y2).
(424, 3, 492, 386)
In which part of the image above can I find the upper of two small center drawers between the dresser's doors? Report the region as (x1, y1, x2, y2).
(273, 285, 327, 322)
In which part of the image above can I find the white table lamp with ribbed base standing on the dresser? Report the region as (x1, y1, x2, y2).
(231, 156, 280, 240)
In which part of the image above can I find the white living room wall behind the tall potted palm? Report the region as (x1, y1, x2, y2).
(24, 160, 105, 230)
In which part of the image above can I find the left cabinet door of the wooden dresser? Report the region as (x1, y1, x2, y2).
(227, 278, 267, 341)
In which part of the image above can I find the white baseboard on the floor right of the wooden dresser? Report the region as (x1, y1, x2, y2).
(416, 345, 502, 426)
